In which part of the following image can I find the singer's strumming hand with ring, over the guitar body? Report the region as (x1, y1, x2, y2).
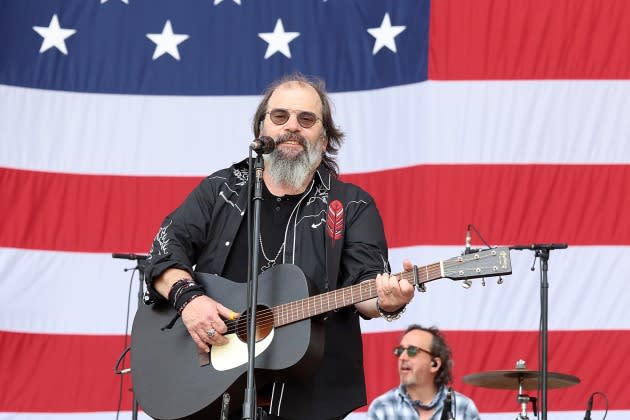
(182, 295, 239, 353)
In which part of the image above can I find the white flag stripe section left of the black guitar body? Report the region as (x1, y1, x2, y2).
(0, 248, 139, 334)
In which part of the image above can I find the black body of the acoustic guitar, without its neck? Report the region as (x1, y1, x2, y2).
(131, 264, 324, 420)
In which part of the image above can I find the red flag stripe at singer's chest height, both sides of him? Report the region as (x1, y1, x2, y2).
(0, 165, 630, 252)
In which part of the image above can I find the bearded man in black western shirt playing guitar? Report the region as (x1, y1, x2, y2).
(145, 74, 413, 420)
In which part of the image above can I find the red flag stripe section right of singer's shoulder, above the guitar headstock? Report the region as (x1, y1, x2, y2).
(344, 165, 630, 247)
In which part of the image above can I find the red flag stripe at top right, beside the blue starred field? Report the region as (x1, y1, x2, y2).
(429, 0, 630, 80)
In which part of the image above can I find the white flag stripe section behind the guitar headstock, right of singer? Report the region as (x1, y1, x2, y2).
(361, 244, 630, 332)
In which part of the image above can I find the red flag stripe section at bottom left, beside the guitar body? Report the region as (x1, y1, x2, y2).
(0, 331, 132, 412)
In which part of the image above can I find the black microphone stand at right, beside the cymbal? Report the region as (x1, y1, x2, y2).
(510, 243, 568, 420)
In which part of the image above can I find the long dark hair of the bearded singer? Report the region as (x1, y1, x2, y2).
(253, 73, 344, 177)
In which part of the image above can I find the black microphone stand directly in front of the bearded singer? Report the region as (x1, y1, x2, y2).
(243, 150, 265, 420)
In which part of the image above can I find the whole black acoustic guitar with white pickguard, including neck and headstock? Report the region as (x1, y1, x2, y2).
(131, 248, 512, 420)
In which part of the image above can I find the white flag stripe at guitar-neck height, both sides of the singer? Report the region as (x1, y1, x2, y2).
(0, 245, 630, 334)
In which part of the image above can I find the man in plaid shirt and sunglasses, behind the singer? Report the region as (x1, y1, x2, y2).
(368, 324, 480, 420)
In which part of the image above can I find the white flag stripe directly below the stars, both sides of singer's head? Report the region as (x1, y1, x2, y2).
(0, 80, 630, 176)
